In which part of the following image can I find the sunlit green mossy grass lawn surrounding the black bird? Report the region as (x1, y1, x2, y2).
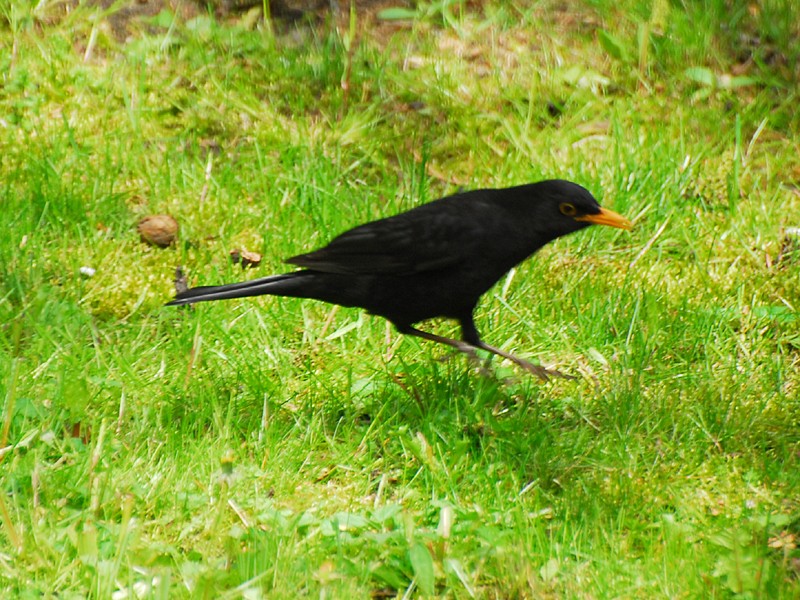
(0, 0, 800, 598)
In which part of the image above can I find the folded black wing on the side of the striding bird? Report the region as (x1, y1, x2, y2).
(286, 206, 476, 275)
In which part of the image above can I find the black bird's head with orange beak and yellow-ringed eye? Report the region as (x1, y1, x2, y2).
(534, 179, 633, 236)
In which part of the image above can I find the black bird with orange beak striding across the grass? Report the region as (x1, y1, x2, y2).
(168, 180, 631, 380)
